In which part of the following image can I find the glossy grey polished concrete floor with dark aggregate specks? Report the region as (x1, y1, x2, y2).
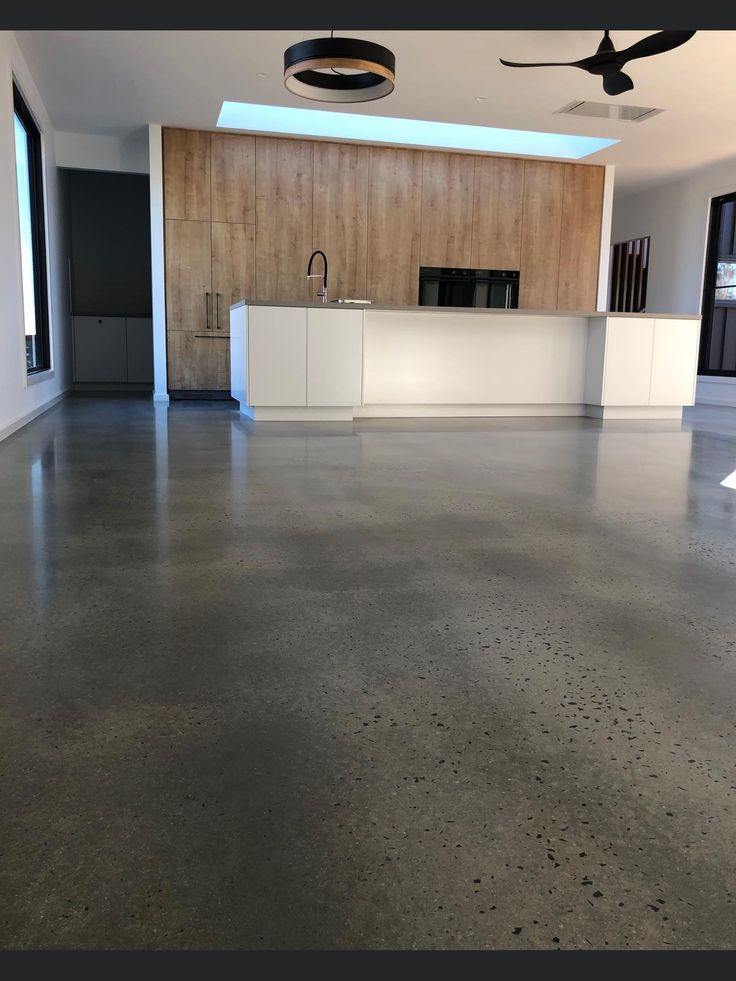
(0, 398, 736, 949)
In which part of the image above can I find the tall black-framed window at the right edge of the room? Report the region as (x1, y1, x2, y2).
(698, 193, 736, 376)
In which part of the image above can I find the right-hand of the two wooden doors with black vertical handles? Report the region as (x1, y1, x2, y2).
(212, 221, 256, 334)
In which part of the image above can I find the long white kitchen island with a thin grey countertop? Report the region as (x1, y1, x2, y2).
(230, 301, 700, 421)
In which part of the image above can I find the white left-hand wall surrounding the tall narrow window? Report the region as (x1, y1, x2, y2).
(0, 31, 71, 439)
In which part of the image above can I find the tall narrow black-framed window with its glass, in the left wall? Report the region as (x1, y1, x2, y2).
(13, 83, 51, 374)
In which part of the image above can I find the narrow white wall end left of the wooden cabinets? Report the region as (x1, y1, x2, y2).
(148, 123, 169, 402)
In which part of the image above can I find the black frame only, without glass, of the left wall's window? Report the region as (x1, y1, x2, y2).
(13, 80, 51, 375)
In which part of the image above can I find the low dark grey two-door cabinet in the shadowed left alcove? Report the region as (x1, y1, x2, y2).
(74, 317, 153, 385)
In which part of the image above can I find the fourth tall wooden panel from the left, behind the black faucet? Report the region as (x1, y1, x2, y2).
(308, 143, 370, 300)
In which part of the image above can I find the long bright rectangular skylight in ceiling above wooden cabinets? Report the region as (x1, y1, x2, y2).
(217, 102, 619, 160)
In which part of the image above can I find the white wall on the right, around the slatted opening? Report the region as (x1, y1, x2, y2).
(611, 157, 736, 314)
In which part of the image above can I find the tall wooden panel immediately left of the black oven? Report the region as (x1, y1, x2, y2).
(367, 147, 422, 306)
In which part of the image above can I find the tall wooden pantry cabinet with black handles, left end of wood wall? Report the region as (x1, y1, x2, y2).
(163, 129, 255, 392)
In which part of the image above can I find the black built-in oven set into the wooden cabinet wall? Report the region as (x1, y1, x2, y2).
(419, 266, 519, 309)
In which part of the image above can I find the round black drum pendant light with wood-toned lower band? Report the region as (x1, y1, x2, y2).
(284, 31, 396, 102)
